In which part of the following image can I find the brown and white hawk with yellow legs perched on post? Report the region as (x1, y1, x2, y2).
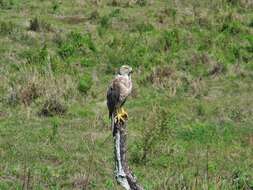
(107, 65, 133, 122)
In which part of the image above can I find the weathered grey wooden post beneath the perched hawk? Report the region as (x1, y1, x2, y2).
(112, 121, 144, 190)
